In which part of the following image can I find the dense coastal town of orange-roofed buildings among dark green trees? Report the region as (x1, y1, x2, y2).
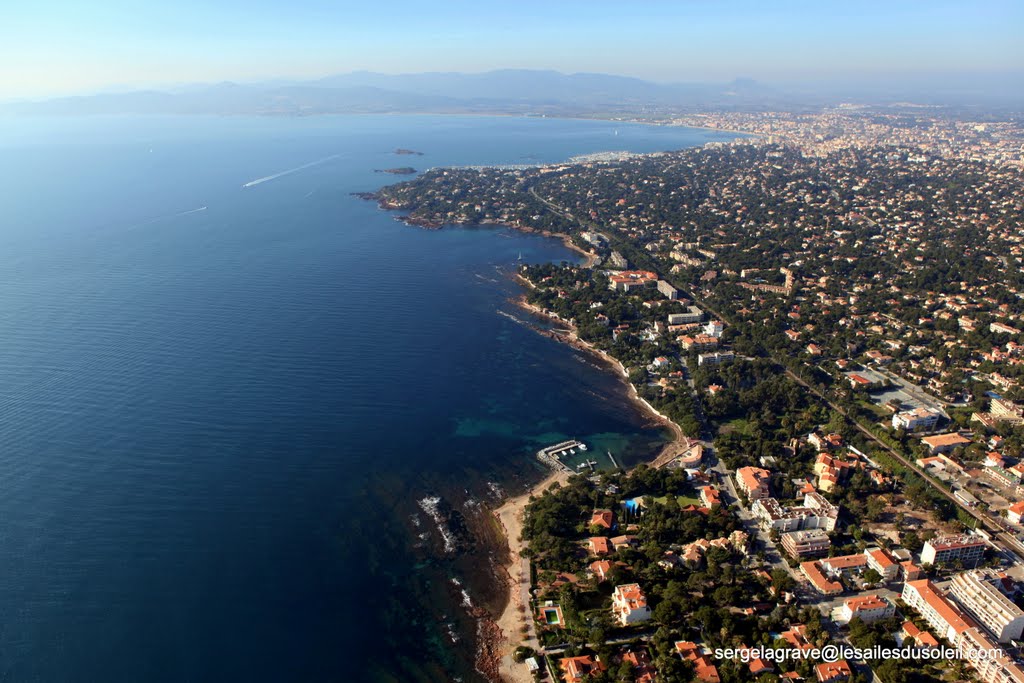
(375, 108, 1024, 683)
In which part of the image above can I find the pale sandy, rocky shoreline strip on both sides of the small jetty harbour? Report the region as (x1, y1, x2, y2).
(493, 280, 689, 683)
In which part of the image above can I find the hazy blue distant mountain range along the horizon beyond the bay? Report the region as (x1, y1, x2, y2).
(0, 70, 1019, 116)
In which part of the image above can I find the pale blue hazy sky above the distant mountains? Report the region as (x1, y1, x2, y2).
(0, 0, 1024, 99)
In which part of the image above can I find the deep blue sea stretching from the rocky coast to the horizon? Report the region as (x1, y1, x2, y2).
(0, 116, 727, 683)
